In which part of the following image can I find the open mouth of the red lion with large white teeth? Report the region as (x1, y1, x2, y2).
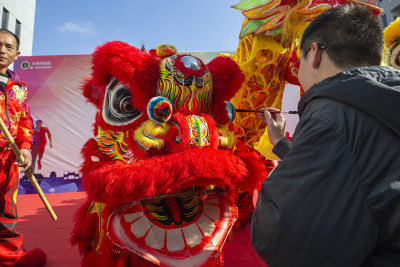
(107, 188, 237, 266)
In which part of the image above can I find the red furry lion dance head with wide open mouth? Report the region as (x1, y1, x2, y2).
(71, 41, 266, 266)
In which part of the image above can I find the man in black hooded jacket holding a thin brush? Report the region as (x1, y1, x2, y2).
(252, 5, 400, 267)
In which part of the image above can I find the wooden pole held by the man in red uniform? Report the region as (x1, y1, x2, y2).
(0, 119, 57, 221)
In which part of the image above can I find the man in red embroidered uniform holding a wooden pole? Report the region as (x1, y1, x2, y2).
(0, 29, 46, 266)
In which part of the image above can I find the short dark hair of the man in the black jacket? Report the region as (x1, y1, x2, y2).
(300, 4, 383, 69)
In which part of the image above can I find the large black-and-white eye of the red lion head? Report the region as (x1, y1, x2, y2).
(103, 79, 142, 126)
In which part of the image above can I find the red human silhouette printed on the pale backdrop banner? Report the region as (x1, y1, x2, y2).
(32, 120, 53, 172)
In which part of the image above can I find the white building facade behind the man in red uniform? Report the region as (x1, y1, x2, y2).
(0, 0, 36, 56)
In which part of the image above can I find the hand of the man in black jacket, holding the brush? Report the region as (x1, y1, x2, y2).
(258, 108, 286, 145)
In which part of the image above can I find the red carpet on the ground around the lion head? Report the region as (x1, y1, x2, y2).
(17, 192, 266, 267)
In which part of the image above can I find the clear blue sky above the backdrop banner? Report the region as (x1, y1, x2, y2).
(32, 0, 244, 56)
